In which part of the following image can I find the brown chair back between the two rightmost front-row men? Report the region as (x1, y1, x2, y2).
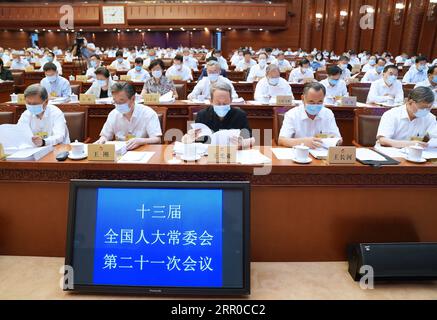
(352, 108, 390, 148)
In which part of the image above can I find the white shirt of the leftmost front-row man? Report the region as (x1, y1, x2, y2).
(18, 104, 70, 146)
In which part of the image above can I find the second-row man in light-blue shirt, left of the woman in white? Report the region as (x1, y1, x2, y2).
(41, 62, 71, 99)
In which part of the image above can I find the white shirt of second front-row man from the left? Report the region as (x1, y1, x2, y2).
(100, 104, 162, 141)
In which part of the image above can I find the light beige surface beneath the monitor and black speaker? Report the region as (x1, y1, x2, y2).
(0, 256, 437, 300)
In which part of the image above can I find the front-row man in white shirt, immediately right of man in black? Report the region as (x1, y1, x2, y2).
(279, 82, 342, 149)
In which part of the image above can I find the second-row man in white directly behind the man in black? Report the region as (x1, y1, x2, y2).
(188, 60, 238, 100)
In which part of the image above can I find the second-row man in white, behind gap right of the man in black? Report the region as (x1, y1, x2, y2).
(255, 64, 294, 103)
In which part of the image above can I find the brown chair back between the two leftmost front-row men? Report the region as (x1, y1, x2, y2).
(60, 106, 90, 143)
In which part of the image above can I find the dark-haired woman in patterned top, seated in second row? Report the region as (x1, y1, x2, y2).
(141, 59, 178, 99)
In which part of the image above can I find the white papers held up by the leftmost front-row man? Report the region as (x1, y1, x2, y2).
(0, 124, 35, 154)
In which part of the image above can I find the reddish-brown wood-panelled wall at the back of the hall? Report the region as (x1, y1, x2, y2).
(0, 0, 437, 57)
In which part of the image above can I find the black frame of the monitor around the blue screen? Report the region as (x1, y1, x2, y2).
(64, 179, 250, 296)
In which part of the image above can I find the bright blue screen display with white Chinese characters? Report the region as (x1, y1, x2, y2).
(93, 188, 223, 288)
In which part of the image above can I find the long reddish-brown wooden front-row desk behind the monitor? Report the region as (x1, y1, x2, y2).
(0, 145, 437, 262)
